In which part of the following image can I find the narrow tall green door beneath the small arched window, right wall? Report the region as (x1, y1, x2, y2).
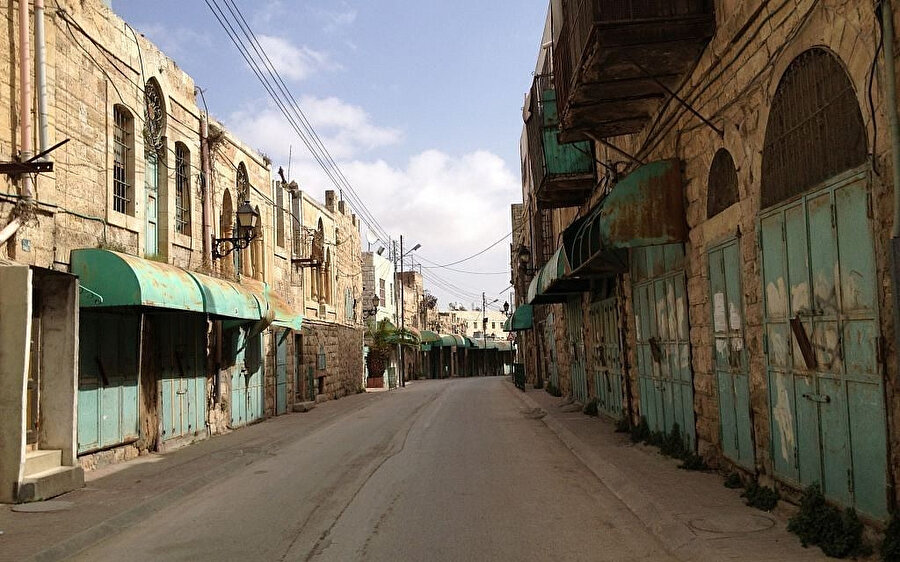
(709, 239, 755, 471)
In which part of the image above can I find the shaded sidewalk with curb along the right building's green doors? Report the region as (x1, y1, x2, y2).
(509, 382, 828, 562)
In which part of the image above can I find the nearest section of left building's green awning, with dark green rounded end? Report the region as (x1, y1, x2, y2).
(71, 248, 204, 313)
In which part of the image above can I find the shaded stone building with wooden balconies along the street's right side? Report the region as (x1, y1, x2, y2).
(513, 0, 900, 520)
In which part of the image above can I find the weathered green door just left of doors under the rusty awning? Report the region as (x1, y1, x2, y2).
(590, 297, 625, 419)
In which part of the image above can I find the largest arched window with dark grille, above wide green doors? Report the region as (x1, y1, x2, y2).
(761, 48, 868, 207)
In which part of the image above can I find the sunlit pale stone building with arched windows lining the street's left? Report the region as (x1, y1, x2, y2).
(0, 0, 362, 501)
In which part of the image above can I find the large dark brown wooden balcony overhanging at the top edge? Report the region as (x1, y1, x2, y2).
(553, 0, 716, 142)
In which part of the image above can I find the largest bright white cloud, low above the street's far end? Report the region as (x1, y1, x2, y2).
(227, 98, 521, 306)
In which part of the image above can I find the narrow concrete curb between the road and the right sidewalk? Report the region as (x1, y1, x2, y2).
(510, 382, 718, 560)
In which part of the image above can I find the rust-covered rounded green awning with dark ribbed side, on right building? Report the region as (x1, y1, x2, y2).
(563, 160, 687, 278)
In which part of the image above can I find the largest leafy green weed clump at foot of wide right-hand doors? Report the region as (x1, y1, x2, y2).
(788, 484, 870, 558)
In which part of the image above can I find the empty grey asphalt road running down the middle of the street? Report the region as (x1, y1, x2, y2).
(77, 378, 671, 561)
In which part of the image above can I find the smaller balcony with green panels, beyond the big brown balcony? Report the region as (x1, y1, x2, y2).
(525, 74, 596, 209)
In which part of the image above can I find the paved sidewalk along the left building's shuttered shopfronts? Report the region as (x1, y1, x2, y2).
(0, 393, 384, 562)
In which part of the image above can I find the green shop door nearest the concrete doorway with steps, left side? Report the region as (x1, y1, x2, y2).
(78, 310, 141, 454)
